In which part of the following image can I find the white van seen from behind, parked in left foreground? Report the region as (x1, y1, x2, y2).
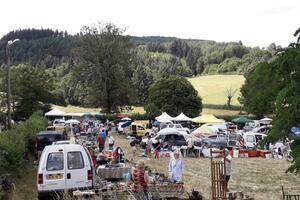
(37, 144, 95, 199)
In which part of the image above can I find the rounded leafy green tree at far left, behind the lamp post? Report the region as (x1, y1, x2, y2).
(0, 65, 57, 117)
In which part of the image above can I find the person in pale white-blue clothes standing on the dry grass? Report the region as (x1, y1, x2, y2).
(169, 151, 184, 182)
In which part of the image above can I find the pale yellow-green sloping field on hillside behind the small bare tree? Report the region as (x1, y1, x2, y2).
(188, 75, 245, 105)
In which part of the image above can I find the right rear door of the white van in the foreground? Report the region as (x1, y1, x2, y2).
(66, 147, 91, 189)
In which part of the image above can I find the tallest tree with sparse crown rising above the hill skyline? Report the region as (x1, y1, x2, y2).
(75, 23, 134, 113)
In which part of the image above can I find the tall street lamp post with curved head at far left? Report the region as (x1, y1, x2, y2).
(6, 39, 19, 129)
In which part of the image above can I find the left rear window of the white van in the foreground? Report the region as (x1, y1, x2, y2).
(46, 152, 64, 171)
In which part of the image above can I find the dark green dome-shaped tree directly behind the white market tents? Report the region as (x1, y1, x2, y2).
(145, 76, 202, 117)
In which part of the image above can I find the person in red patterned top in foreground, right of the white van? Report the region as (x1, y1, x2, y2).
(132, 161, 149, 200)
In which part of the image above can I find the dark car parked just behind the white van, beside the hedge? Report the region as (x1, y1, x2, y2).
(35, 131, 67, 159)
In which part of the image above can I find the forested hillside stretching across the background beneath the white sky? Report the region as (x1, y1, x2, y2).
(0, 25, 279, 116)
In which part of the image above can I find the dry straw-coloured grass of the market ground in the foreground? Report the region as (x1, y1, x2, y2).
(114, 131, 300, 200)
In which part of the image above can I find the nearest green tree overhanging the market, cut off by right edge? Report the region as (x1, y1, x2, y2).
(267, 37, 300, 173)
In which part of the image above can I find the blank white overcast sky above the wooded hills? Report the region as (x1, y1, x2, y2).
(0, 0, 300, 47)
